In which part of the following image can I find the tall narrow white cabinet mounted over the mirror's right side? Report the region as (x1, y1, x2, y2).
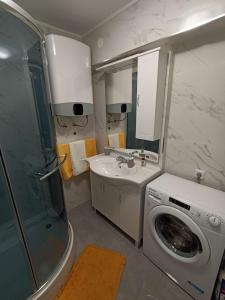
(136, 49, 167, 141)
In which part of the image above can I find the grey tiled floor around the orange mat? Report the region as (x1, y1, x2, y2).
(69, 203, 192, 300)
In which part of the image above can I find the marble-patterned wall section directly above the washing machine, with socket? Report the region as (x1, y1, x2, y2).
(165, 40, 225, 191)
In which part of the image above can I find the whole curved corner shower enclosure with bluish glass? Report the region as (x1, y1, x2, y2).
(0, 1, 73, 300)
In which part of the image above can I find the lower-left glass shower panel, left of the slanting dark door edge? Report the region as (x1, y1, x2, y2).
(0, 155, 36, 300)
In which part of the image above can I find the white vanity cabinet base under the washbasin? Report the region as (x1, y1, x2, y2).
(91, 172, 145, 245)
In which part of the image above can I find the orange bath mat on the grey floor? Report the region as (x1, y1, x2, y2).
(56, 245, 126, 300)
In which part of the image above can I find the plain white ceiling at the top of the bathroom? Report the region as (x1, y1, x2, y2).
(14, 0, 136, 36)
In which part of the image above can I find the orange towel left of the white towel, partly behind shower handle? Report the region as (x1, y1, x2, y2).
(57, 144, 73, 180)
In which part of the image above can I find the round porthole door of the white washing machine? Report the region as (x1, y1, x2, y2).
(148, 205, 210, 265)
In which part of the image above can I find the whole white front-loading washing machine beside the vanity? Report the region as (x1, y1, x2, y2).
(143, 173, 225, 300)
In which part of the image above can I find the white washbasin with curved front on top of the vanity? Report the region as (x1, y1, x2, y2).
(87, 154, 161, 185)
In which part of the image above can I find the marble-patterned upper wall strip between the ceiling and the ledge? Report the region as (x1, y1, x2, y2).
(83, 0, 225, 64)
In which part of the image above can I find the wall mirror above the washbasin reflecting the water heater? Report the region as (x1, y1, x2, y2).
(105, 65, 159, 153)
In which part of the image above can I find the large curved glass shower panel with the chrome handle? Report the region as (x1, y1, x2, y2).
(0, 10, 68, 287)
